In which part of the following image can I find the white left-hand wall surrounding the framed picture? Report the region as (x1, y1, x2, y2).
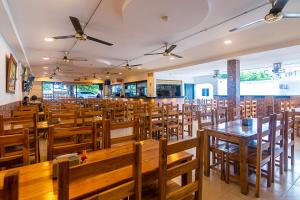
(0, 34, 22, 105)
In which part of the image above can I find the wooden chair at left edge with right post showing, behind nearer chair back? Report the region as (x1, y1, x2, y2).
(0, 113, 40, 162)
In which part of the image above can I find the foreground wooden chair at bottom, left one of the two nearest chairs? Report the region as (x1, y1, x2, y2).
(58, 143, 142, 200)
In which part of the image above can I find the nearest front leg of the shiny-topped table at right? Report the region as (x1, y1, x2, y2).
(240, 141, 249, 195)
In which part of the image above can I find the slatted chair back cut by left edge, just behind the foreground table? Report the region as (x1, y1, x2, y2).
(0, 129, 30, 168)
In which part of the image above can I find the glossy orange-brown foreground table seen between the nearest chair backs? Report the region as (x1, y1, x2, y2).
(0, 139, 192, 200)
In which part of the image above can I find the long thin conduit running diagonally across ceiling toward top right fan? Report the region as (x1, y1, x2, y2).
(118, 2, 270, 67)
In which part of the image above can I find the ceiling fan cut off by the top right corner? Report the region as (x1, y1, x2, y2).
(229, 0, 300, 32)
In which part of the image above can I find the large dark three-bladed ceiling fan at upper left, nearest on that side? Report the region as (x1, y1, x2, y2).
(52, 16, 113, 46)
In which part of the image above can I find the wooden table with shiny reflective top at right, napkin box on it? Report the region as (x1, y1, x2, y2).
(204, 118, 269, 194)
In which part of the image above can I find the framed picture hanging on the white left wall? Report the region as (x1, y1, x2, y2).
(6, 54, 17, 94)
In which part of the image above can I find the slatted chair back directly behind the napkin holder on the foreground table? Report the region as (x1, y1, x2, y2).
(47, 123, 97, 160)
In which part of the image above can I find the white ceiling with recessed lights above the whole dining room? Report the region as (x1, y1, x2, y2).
(3, 0, 300, 77)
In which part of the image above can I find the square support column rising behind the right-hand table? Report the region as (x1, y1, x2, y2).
(227, 59, 240, 120)
